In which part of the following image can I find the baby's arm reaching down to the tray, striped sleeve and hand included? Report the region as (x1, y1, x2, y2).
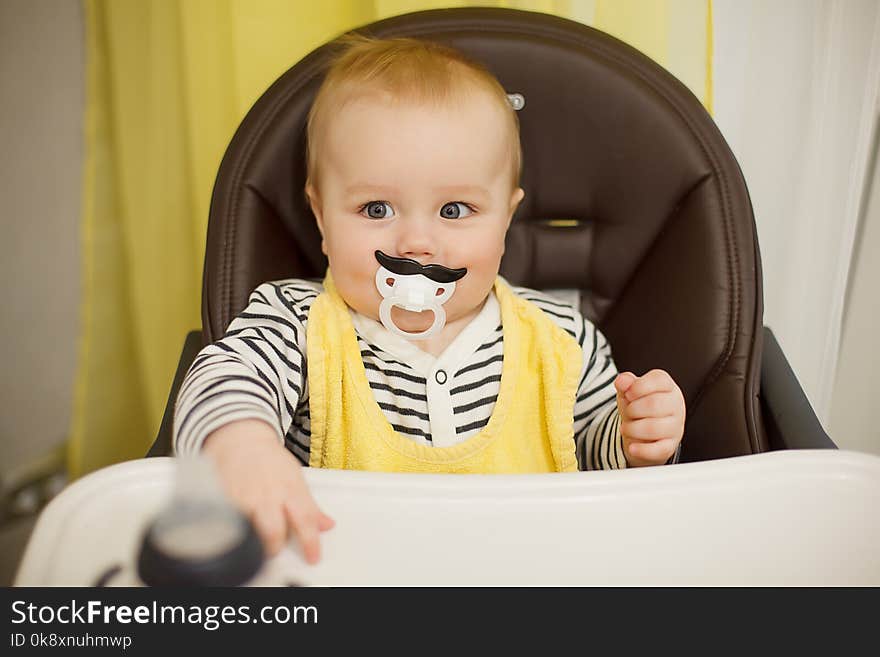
(174, 284, 332, 561)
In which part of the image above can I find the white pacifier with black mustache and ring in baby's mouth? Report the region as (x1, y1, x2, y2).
(375, 251, 467, 340)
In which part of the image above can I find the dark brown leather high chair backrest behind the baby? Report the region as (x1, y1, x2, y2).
(203, 8, 767, 461)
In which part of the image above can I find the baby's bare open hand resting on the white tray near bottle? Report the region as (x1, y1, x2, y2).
(203, 420, 334, 563)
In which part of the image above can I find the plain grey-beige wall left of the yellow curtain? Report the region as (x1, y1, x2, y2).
(0, 0, 84, 480)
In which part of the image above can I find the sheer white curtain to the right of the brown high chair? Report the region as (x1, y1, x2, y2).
(713, 0, 880, 426)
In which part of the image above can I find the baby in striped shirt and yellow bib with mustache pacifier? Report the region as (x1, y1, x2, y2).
(175, 33, 685, 563)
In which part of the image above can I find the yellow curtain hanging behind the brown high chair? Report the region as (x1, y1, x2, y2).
(69, 0, 711, 477)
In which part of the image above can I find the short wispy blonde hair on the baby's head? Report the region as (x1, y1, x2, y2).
(306, 34, 522, 187)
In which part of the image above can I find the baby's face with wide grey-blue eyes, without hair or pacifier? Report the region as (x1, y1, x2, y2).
(307, 94, 523, 332)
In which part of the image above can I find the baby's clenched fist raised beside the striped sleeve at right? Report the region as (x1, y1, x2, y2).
(614, 370, 685, 467)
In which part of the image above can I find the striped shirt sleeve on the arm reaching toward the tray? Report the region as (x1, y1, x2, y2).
(174, 283, 317, 453)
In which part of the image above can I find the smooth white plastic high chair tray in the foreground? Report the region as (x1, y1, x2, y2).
(15, 450, 880, 586)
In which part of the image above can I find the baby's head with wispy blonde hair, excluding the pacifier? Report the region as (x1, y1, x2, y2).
(306, 37, 523, 332)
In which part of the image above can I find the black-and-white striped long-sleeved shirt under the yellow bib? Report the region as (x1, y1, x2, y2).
(174, 279, 626, 470)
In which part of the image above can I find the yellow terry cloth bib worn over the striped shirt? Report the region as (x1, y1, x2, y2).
(306, 272, 583, 473)
